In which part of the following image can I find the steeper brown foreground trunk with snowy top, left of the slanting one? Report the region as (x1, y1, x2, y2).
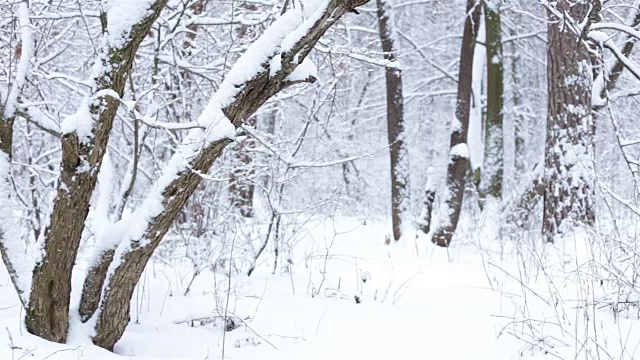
(26, 0, 167, 342)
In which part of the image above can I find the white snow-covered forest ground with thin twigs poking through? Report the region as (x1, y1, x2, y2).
(0, 221, 640, 360)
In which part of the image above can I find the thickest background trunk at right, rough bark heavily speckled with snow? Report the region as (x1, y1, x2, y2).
(542, 0, 595, 242)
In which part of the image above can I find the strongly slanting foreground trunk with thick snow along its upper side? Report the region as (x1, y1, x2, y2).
(93, 0, 367, 350)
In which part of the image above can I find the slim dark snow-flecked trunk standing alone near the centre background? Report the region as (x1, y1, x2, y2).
(376, 0, 411, 241)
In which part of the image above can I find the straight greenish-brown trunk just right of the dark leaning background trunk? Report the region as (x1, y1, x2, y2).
(481, 0, 504, 199)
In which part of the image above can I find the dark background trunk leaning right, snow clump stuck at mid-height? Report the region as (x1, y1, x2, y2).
(432, 0, 481, 247)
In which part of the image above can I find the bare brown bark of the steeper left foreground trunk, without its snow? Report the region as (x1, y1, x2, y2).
(26, 0, 167, 342)
